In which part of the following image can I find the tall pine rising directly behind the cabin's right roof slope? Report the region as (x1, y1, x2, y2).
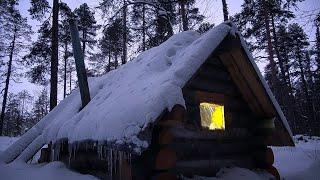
(234, 0, 302, 134)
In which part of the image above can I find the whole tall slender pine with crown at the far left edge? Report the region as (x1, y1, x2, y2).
(0, 2, 32, 135)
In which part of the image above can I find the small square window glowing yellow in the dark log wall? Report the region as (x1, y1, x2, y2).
(200, 103, 225, 130)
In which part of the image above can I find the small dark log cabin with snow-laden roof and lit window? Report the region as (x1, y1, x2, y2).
(1, 22, 294, 179)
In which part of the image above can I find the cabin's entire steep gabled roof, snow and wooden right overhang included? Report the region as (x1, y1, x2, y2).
(1, 23, 293, 162)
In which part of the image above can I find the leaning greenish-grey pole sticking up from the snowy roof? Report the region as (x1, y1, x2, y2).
(69, 18, 90, 108)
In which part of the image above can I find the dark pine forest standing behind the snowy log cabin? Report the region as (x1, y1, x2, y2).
(0, 0, 320, 136)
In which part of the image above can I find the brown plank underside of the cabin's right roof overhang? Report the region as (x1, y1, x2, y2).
(217, 37, 276, 117)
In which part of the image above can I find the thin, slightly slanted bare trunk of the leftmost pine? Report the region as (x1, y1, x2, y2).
(0, 27, 17, 136)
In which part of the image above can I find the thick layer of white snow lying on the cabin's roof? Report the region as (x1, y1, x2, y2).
(3, 23, 291, 159)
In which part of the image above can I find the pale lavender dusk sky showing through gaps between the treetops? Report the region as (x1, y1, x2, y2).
(10, 0, 320, 102)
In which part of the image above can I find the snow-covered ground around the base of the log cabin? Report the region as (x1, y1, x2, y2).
(0, 136, 320, 180)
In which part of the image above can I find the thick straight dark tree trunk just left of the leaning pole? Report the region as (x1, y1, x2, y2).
(50, 0, 59, 111)
